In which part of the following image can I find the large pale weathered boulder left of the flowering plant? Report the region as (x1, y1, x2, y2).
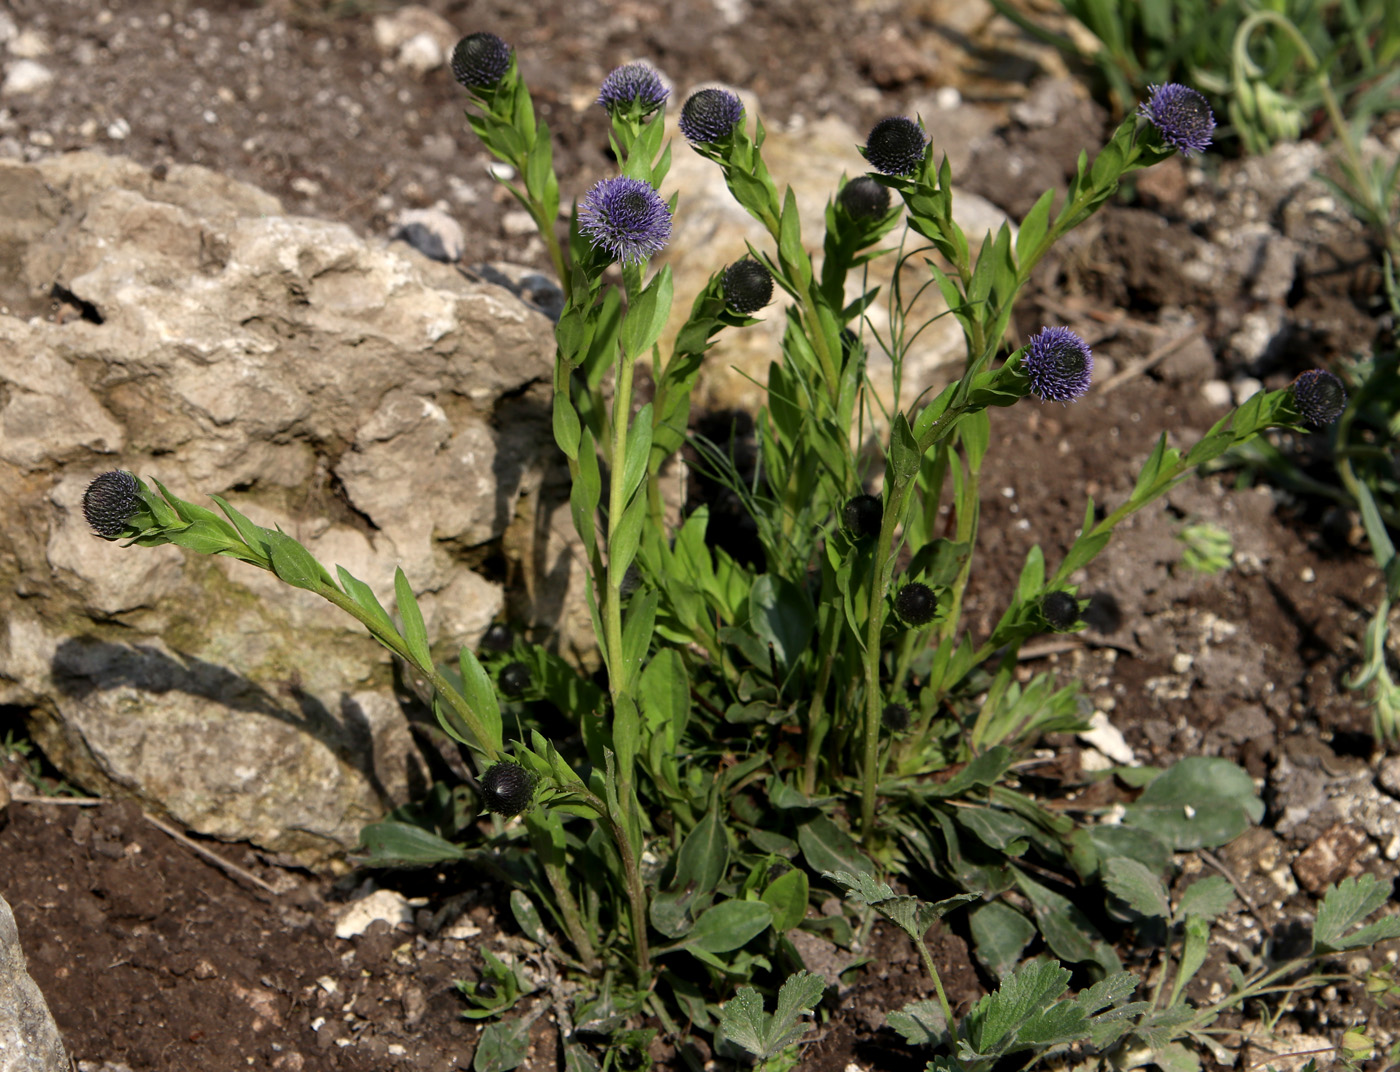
(0, 153, 553, 862)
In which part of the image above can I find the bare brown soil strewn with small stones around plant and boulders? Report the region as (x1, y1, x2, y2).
(0, 0, 1396, 1072)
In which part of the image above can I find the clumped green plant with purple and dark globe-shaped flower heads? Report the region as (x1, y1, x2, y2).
(84, 34, 1355, 1069)
